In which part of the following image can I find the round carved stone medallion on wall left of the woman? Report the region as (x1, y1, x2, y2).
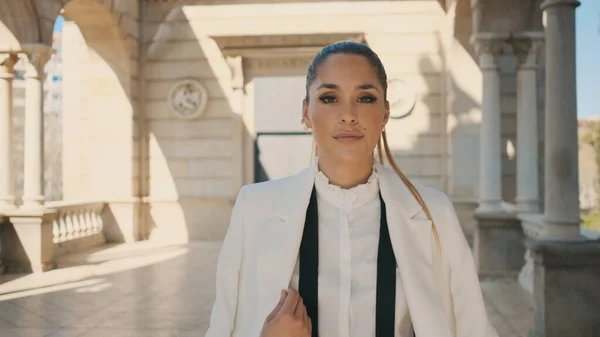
(169, 79, 208, 119)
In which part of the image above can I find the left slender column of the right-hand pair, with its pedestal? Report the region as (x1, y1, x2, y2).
(472, 33, 525, 276)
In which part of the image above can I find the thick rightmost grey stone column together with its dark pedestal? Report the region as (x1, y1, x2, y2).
(521, 0, 600, 337)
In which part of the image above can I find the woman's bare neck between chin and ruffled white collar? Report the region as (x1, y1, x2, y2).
(319, 156, 373, 189)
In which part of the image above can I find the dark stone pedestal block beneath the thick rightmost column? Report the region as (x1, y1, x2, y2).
(526, 239, 600, 337)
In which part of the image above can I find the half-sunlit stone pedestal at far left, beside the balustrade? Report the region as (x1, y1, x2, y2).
(1, 208, 56, 273)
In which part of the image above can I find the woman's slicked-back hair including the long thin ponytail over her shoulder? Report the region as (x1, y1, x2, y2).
(305, 41, 440, 247)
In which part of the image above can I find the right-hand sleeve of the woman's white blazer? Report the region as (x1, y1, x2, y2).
(444, 196, 498, 337)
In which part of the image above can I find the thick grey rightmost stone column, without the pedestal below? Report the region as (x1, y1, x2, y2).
(542, 0, 580, 240)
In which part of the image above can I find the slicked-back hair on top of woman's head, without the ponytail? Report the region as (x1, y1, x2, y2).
(305, 41, 387, 101)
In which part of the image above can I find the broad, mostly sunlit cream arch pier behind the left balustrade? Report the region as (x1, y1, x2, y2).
(44, 0, 139, 241)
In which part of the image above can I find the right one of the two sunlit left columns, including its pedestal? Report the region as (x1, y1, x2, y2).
(0, 45, 56, 272)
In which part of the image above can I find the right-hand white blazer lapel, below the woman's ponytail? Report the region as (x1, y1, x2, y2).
(376, 165, 452, 337)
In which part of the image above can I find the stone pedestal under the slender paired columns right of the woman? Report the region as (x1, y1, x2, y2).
(473, 211, 525, 276)
